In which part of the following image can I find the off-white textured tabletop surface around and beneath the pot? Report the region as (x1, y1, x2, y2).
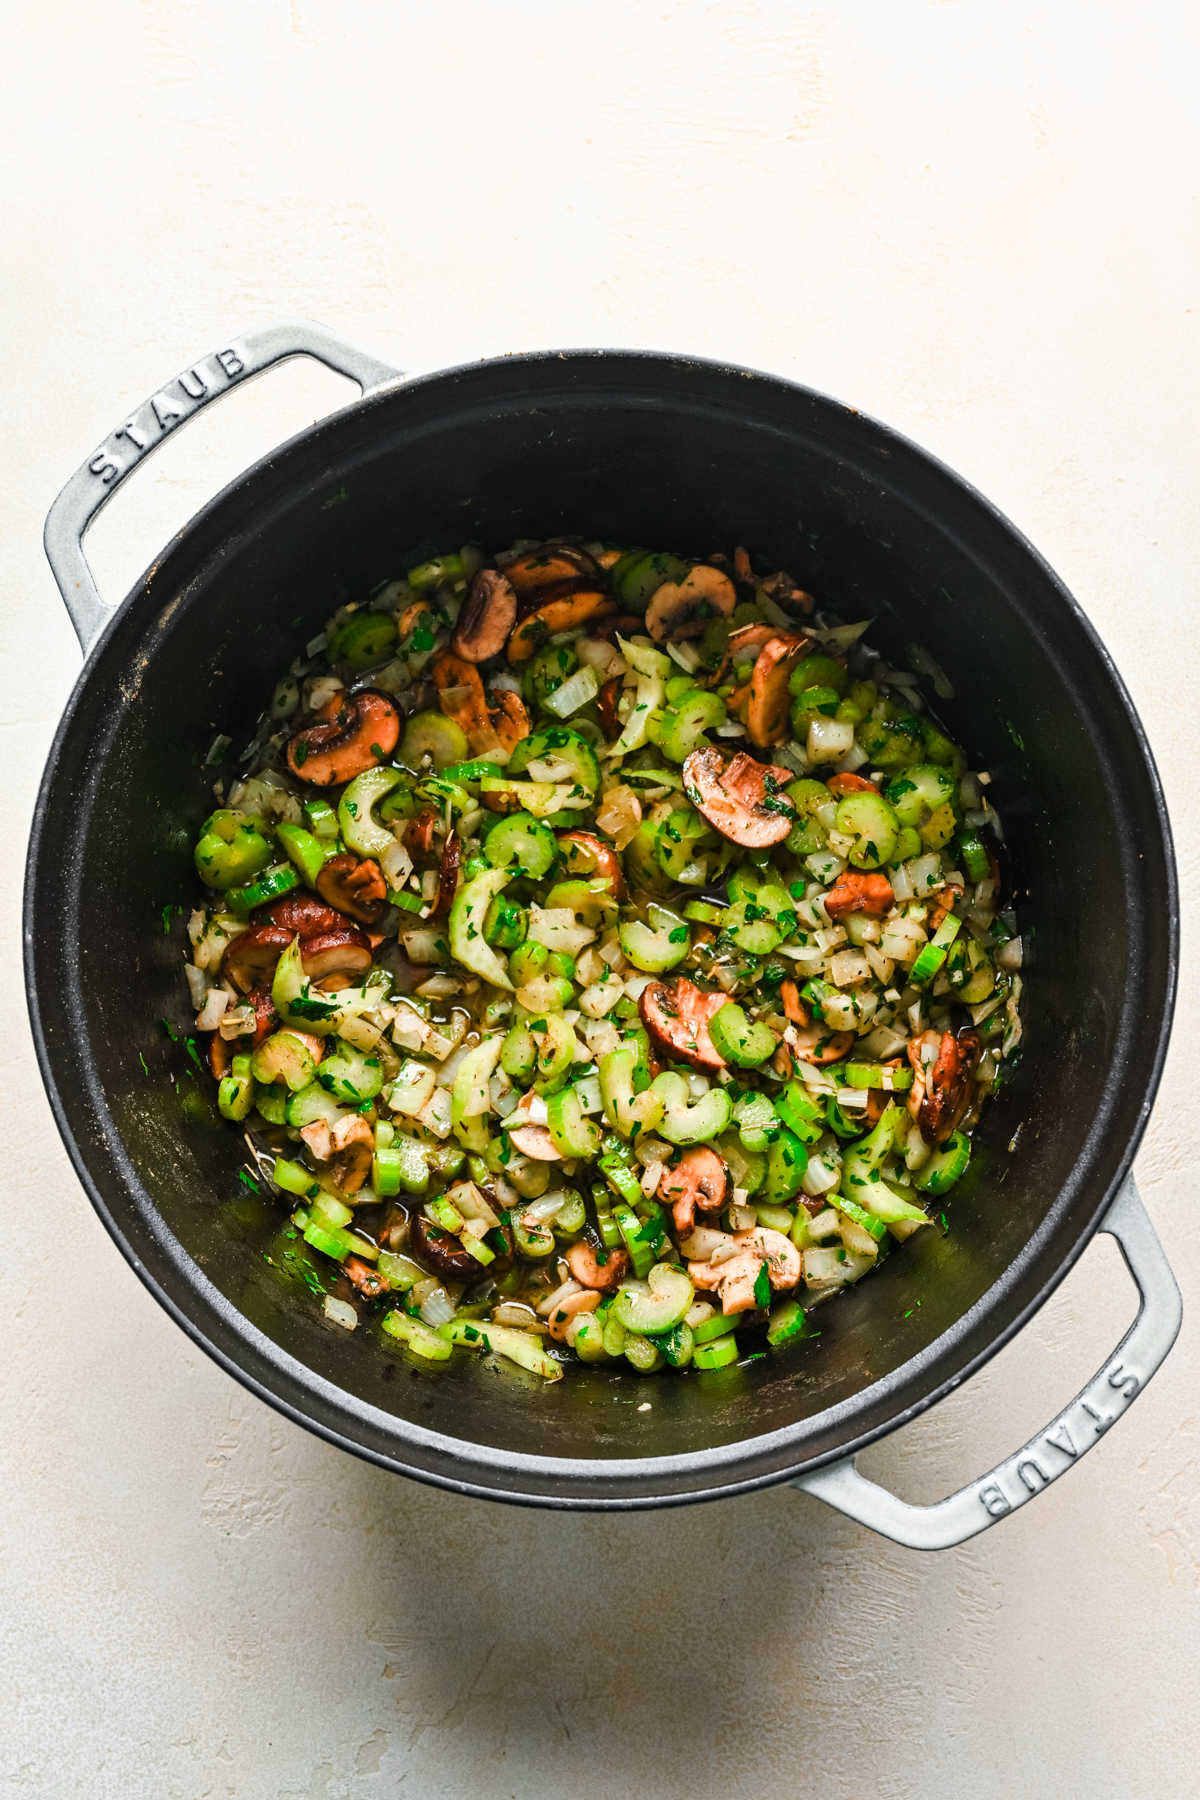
(0, 0, 1200, 1800)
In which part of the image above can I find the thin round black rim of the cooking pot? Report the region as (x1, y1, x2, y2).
(23, 347, 1180, 1510)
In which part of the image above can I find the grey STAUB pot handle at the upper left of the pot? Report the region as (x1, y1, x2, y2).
(43, 319, 399, 655)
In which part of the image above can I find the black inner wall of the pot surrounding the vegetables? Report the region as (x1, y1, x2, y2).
(34, 356, 1169, 1490)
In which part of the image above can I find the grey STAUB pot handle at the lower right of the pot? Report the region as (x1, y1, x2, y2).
(790, 1175, 1184, 1550)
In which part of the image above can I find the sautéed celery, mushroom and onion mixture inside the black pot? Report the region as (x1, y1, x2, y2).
(185, 542, 1022, 1381)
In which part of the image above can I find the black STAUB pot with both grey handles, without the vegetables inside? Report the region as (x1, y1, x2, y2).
(25, 326, 1180, 1548)
